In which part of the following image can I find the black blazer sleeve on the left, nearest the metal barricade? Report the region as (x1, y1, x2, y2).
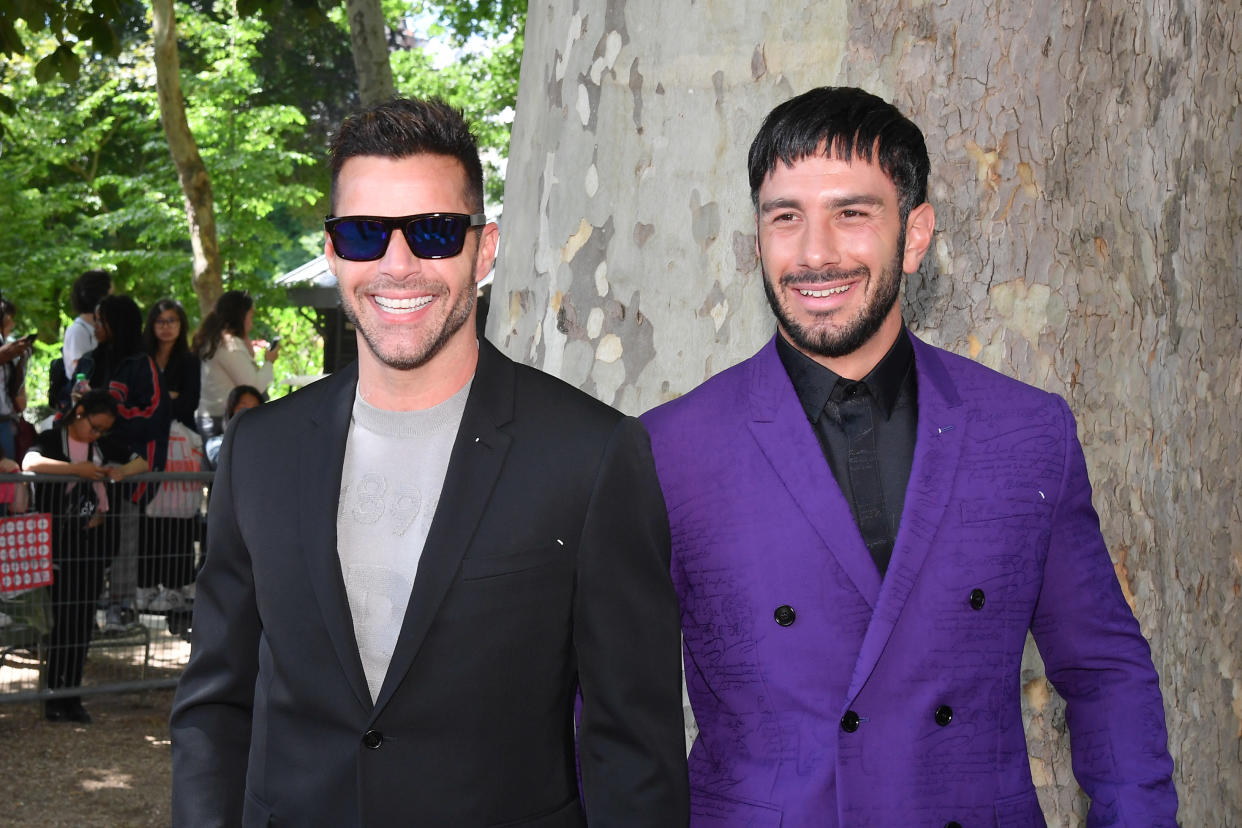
(170, 418, 261, 828)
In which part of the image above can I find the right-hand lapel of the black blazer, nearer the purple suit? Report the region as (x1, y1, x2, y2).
(375, 340, 514, 713)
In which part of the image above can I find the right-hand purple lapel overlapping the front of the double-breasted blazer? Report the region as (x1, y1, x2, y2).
(846, 334, 966, 706)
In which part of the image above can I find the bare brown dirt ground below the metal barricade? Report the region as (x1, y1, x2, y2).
(0, 690, 173, 828)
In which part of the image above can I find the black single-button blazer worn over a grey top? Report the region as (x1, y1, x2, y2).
(171, 341, 688, 827)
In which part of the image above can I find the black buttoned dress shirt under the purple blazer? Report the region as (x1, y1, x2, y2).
(776, 328, 918, 576)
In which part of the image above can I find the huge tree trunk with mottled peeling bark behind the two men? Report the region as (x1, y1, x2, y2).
(488, 0, 1242, 826)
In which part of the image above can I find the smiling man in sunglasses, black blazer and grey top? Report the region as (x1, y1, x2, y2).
(171, 101, 688, 828)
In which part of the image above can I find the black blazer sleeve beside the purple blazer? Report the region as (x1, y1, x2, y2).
(574, 417, 689, 828)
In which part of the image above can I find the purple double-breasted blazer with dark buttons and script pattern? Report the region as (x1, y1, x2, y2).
(643, 336, 1177, 828)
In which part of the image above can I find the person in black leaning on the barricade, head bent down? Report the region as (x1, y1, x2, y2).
(22, 390, 147, 724)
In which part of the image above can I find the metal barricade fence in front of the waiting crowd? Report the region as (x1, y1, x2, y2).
(0, 472, 212, 703)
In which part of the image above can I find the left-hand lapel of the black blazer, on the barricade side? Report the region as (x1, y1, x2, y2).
(298, 362, 371, 709)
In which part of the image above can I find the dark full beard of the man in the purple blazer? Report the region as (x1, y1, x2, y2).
(760, 227, 905, 359)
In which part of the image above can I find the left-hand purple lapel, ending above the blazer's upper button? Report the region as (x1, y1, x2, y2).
(749, 338, 881, 608)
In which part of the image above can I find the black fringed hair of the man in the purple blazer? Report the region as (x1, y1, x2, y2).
(746, 86, 932, 223)
